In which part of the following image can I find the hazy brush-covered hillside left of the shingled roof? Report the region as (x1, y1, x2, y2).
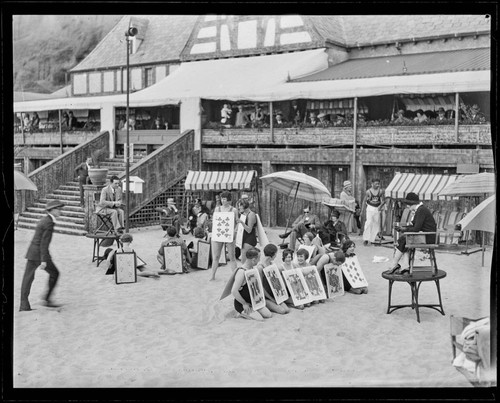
(13, 15, 122, 93)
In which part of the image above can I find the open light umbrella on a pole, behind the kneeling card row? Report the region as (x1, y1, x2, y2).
(260, 171, 332, 242)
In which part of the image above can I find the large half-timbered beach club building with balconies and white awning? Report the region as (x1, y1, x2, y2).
(14, 15, 494, 235)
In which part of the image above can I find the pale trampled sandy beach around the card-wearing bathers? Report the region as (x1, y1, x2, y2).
(13, 226, 491, 388)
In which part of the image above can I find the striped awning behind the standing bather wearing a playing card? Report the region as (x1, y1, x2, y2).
(184, 171, 256, 190)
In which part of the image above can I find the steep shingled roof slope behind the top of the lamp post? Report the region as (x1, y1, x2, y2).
(71, 15, 198, 73)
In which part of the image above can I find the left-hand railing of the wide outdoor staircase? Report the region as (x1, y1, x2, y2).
(23, 131, 109, 209)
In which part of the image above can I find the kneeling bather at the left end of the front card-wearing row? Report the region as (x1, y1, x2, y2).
(231, 249, 273, 320)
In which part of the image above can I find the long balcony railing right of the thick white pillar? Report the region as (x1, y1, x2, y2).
(202, 123, 491, 146)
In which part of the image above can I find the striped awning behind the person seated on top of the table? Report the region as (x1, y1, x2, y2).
(385, 172, 460, 200)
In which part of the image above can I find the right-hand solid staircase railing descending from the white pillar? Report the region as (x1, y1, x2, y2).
(120, 130, 199, 217)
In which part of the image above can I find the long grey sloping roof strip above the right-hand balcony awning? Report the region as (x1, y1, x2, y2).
(293, 48, 491, 82)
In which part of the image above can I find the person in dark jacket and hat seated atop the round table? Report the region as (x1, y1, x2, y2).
(386, 192, 437, 274)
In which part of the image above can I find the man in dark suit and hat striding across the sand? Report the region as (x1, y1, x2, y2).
(19, 200, 64, 311)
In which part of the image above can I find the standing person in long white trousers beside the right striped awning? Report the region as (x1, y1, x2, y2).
(361, 178, 385, 246)
